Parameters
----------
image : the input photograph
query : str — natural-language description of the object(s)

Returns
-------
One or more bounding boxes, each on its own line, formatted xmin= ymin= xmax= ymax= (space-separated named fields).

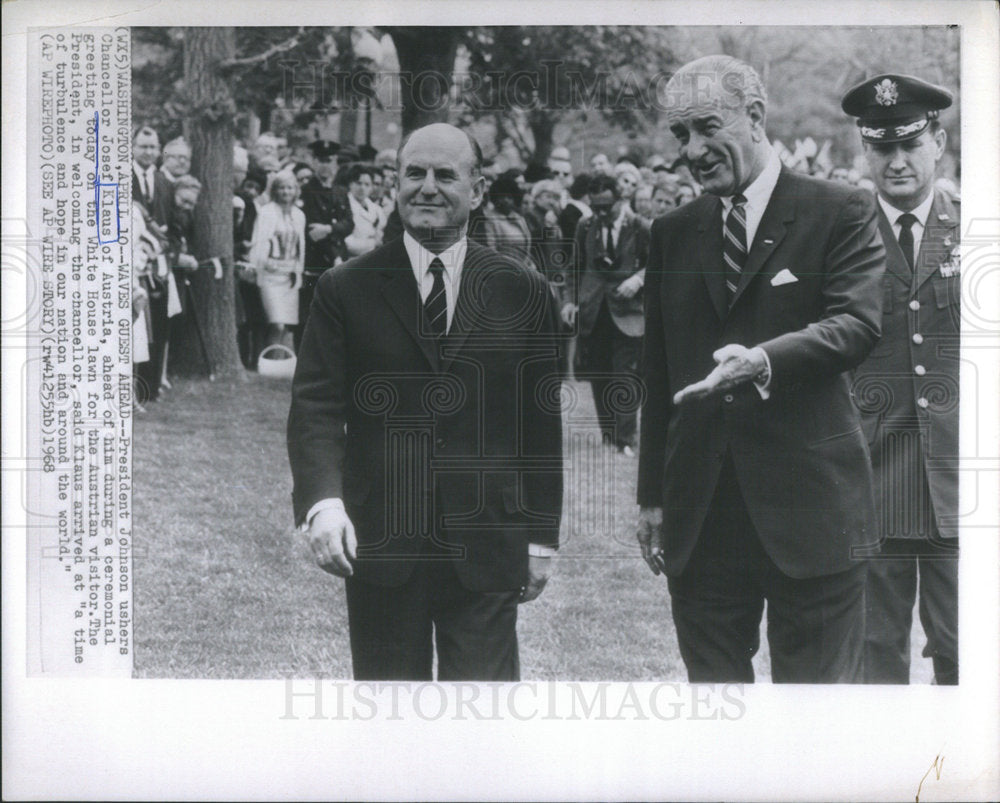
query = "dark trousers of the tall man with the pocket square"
xmin=668 ymin=453 xmax=867 ymax=683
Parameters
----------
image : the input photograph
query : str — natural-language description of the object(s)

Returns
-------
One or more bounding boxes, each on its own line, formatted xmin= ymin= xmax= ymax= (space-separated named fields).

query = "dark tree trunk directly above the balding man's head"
xmin=386 ymin=27 xmax=458 ymax=136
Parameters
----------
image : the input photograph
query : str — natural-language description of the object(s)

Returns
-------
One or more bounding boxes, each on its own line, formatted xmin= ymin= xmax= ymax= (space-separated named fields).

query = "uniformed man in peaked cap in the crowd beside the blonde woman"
xmin=295 ymin=139 xmax=354 ymax=351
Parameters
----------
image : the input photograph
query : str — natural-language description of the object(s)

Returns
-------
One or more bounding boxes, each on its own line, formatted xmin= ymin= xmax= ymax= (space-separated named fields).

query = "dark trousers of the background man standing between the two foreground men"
xmin=580 ymin=300 xmax=642 ymax=448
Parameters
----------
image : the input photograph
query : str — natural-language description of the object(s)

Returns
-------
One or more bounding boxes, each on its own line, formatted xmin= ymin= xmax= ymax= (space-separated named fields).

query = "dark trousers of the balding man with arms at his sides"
xmin=346 ymin=545 xmax=520 ymax=681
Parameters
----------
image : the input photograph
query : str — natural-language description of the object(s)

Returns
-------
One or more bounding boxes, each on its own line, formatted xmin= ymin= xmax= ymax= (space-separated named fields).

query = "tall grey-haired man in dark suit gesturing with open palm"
xmin=638 ymin=56 xmax=885 ymax=683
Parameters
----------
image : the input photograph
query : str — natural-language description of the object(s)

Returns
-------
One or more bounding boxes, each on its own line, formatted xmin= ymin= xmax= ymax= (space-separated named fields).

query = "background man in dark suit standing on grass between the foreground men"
xmin=562 ymin=175 xmax=649 ymax=457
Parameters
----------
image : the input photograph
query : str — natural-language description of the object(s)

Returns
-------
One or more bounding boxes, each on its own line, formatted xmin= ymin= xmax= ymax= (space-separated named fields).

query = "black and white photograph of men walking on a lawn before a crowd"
xmin=132 ymin=26 xmax=961 ymax=684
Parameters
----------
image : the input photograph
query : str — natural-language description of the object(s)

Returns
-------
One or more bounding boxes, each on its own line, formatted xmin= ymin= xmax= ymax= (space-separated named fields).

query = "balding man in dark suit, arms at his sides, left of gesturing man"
xmin=288 ymin=124 xmax=562 ymax=680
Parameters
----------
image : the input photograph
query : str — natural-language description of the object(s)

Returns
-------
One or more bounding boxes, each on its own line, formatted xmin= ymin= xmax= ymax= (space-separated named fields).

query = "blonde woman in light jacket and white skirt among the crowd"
xmin=249 ymin=171 xmax=306 ymax=348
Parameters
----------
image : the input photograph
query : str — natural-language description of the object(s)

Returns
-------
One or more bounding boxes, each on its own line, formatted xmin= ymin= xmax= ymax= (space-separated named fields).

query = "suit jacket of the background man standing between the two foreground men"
xmin=563 ymin=215 xmax=649 ymax=337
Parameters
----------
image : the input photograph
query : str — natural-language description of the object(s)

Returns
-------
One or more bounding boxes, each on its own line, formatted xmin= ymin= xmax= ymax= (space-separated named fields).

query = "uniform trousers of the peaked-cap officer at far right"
xmin=864 ymin=538 xmax=958 ymax=686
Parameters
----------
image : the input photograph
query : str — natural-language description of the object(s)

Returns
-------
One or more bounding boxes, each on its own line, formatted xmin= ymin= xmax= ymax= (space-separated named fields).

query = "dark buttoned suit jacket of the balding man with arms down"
xmin=288 ymin=239 xmax=562 ymax=591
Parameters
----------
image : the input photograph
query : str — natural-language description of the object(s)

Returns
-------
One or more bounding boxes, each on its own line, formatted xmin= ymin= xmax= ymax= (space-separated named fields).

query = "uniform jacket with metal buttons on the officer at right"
xmin=854 ymin=191 xmax=962 ymax=538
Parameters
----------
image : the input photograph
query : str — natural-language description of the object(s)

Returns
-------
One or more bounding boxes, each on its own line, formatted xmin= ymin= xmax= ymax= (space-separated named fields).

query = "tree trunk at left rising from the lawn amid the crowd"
xmin=170 ymin=27 xmax=243 ymax=376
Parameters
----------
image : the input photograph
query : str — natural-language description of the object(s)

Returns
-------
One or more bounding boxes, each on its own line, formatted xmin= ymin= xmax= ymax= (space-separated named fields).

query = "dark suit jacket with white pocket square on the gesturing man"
xmin=638 ymin=169 xmax=885 ymax=578
